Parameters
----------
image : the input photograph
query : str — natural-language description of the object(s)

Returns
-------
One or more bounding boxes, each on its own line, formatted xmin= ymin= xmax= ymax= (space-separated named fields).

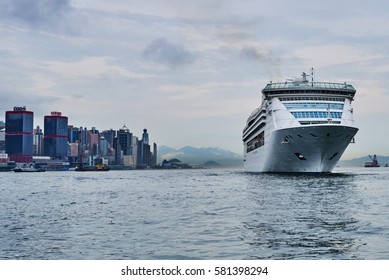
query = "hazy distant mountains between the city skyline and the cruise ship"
xmin=158 ymin=146 xmax=243 ymax=167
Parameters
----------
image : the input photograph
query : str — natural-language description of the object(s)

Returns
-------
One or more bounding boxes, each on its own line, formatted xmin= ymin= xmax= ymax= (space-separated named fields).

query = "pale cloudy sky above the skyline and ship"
xmin=0 ymin=0 xmax=389 ymax=159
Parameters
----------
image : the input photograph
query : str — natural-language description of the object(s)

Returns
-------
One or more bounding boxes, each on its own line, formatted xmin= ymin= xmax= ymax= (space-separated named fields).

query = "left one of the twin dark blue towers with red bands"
xmin=5 ymin=106 xmax=34 ymax=162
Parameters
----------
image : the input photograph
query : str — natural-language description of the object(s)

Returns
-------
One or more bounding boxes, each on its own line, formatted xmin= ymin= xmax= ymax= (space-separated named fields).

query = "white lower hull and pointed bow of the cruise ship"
xmin=244 ymin=125 xmax=358 ymax=173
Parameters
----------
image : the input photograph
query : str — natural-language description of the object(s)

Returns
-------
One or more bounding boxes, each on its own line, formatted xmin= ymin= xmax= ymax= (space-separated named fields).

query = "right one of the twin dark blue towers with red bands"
xmin=44 ymin=112 xmax=68 ymax=158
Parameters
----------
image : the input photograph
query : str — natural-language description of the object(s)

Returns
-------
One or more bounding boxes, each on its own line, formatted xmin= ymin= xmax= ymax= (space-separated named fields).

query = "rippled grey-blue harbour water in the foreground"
xmin=0 ymin=167 xmax=389 ymax=260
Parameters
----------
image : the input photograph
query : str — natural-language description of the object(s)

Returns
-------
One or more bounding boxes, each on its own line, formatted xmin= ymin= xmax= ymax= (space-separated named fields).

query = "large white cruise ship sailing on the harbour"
xmin=243 ymin=71 xmax=358 ymax=173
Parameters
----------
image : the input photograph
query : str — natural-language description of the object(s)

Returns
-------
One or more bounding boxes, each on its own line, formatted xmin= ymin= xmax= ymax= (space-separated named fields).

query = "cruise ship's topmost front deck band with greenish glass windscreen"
xmin=262 ymin=81 xmax=356 ymax=99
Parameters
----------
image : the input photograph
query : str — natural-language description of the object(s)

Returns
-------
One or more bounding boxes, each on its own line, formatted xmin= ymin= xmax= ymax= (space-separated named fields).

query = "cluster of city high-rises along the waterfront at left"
xmin=0 ymin=107 xmax=157 ymax=170
